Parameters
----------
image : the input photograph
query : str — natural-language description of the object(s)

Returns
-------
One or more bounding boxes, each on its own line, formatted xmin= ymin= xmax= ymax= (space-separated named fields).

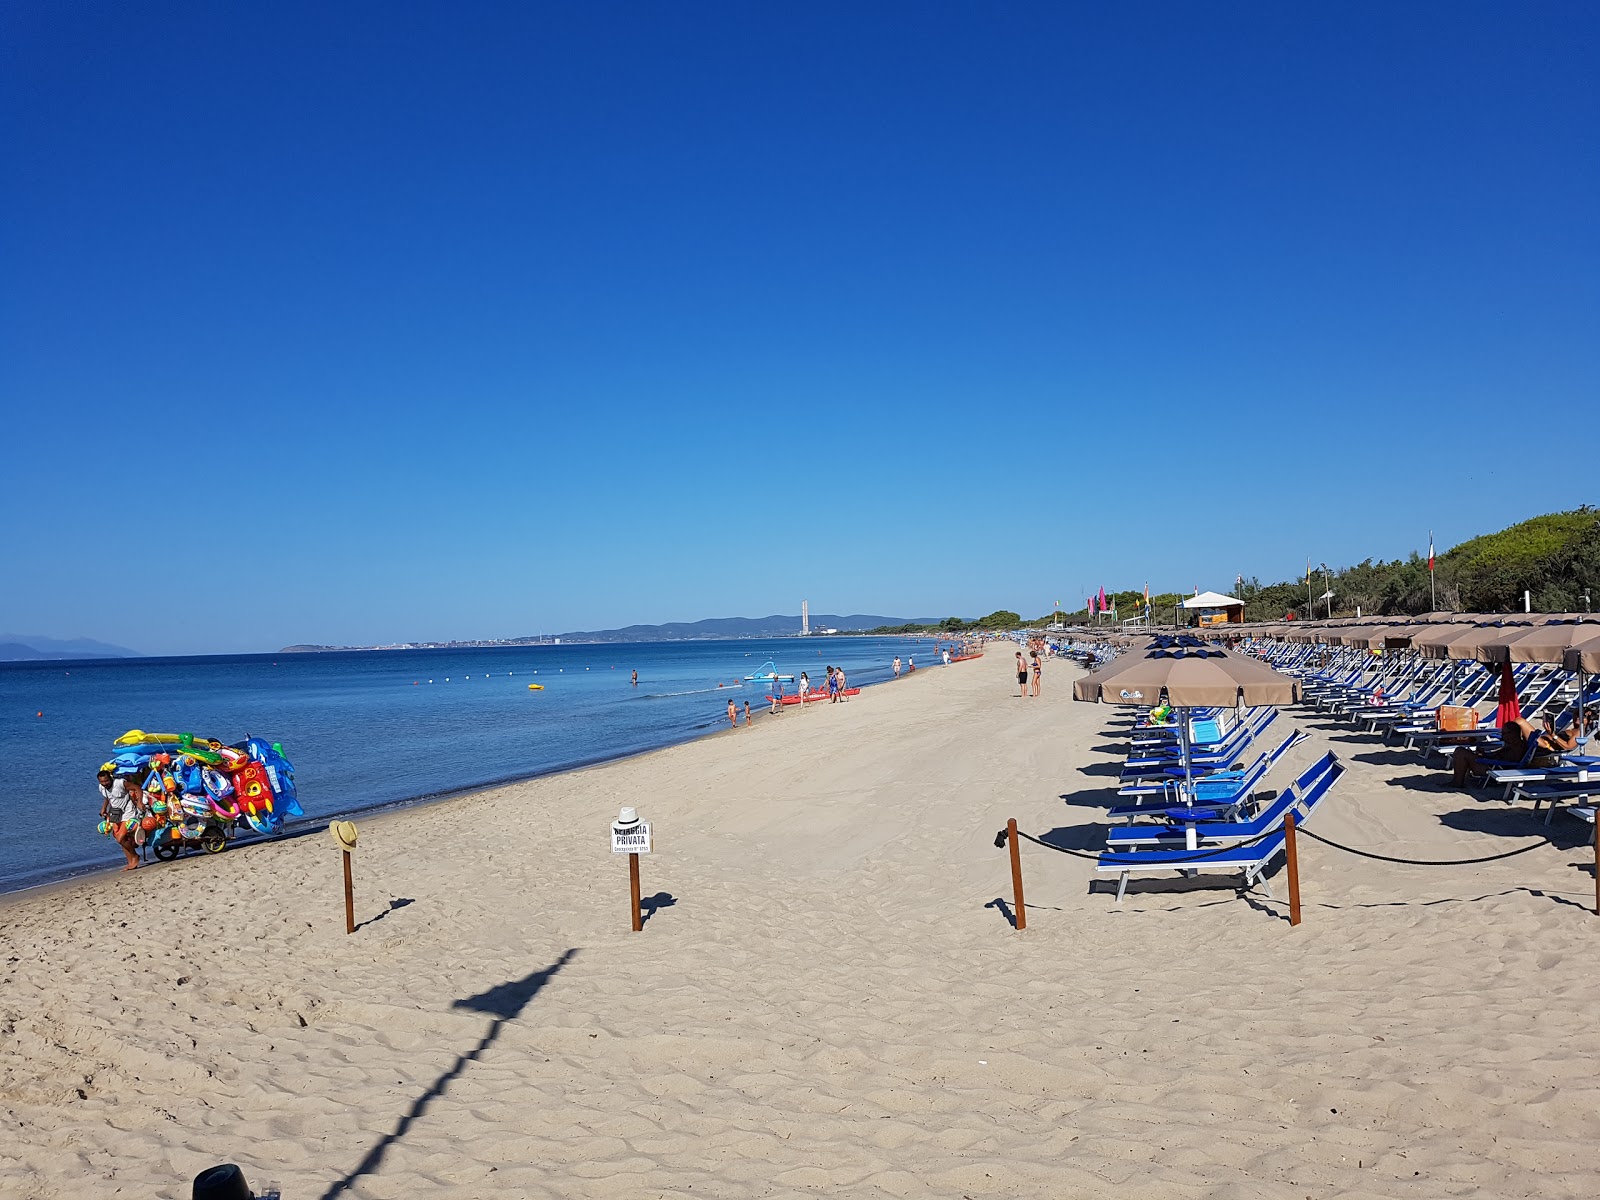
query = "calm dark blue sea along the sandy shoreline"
xmin=0 ymin=637 xmax=934 ymax=891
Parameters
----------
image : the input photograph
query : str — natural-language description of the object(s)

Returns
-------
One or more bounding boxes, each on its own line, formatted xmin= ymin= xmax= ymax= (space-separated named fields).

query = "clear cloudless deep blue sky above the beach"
xmin=0 ymin=0 xmax=1600 ymax=653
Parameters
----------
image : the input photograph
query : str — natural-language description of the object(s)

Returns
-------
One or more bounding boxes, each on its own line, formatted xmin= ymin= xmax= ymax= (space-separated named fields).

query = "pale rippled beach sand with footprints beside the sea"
xmin=0 ymin=653 xmax=1600 ymax=1200
